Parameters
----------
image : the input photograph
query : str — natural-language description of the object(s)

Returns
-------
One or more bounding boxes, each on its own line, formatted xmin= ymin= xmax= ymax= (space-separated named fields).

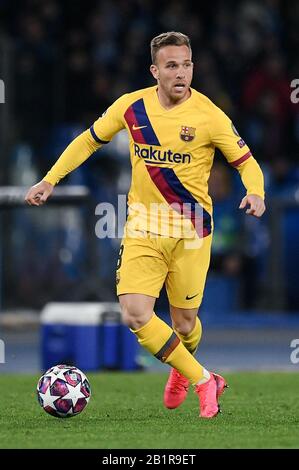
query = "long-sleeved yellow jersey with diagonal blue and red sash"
xmin=44 ymin=86 xmax=264 ymax=238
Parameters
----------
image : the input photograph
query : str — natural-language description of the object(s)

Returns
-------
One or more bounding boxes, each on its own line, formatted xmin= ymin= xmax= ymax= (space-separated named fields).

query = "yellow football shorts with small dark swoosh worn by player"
xmin=116 ymin=230 xmax=212 ymax=308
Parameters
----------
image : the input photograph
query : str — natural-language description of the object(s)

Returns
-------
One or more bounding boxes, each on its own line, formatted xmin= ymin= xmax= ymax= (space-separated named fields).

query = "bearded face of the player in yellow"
xmin=151 ymin=46 xmax=193 ymax=104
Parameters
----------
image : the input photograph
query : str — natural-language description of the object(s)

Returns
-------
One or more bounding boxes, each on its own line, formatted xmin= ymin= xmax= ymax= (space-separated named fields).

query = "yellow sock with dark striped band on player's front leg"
xmin=131 ymin=313 xmax=204 ymax=384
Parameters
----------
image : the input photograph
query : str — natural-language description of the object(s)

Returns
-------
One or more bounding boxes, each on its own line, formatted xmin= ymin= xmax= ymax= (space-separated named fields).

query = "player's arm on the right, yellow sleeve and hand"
xmin=209 ymin=106 xmax=266 ymax=217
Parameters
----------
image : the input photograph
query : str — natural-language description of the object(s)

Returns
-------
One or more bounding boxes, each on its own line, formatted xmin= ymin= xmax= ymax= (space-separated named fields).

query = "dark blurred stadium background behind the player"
xmin=0 ymin=0 xmax=299 ymax=373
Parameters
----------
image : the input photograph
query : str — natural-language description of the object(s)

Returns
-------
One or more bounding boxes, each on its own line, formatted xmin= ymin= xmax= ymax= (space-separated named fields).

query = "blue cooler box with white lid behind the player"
xmin=41 ymin=302 xmax=140 ymax=371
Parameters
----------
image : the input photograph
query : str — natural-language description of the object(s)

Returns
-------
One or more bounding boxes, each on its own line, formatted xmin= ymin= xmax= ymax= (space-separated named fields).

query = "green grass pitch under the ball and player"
xmin=0 ymin=372 xmax=299 ymax=449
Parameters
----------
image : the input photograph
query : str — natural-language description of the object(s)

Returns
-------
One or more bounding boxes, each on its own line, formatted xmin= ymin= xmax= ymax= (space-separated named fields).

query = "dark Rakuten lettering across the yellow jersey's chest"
xmin=134 ymin=144 xmax=192 ymax=163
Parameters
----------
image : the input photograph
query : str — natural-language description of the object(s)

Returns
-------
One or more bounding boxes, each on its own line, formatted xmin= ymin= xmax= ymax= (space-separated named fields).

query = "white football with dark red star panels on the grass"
xmin=37 ymin=364 xmax=91 ymax=418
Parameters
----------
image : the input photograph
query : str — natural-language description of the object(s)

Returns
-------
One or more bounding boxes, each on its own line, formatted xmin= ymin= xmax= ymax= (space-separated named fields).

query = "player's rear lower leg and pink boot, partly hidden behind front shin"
xmin=164 ymin=305 xmax=202 ymax=408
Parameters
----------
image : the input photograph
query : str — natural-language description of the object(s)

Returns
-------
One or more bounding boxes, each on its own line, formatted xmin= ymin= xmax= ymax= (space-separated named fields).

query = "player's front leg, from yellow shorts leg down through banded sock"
xmin=117 ymin=233 xmax=223 ymax=418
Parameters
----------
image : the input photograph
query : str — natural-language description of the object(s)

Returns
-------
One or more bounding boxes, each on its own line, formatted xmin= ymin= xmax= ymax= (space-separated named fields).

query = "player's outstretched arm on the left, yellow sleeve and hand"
xmin=25 ymin=95 xmax=127 ymax=206
